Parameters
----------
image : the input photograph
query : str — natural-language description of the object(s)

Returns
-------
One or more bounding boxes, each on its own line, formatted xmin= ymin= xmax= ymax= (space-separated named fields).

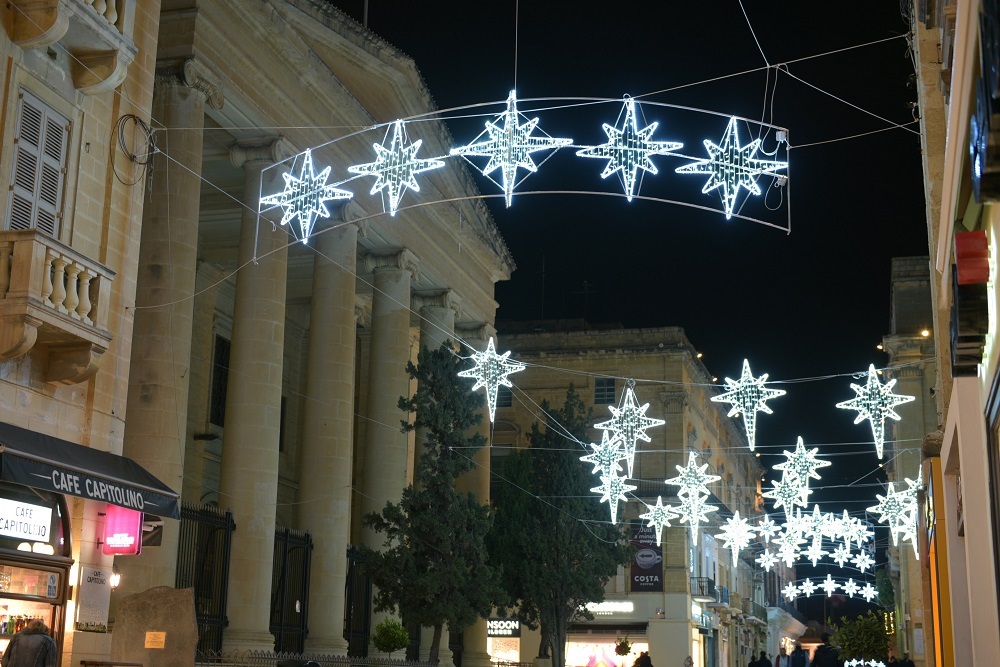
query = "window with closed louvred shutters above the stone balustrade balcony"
xmin=7 ymin=90 xmax=69 ymax=238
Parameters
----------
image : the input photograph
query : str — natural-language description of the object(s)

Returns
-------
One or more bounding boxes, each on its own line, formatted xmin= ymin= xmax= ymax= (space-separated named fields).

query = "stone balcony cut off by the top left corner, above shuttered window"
xmin=4 ymin=0 xmax=137 ymax=95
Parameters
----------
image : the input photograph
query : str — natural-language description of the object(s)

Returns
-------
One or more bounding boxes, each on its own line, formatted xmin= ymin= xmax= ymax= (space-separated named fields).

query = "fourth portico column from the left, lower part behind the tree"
xmin=360 ymin=250 xmax=419 ymax=549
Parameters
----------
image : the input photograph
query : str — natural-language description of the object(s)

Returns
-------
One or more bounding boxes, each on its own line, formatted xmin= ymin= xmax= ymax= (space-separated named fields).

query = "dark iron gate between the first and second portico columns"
xmin=174 ymin=504 xmax=236 ymax=651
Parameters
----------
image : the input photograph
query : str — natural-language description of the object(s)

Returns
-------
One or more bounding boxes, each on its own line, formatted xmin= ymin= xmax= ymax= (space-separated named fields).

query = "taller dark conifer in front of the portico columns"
xmin=362 ymin=345 xmax=500 ymax=663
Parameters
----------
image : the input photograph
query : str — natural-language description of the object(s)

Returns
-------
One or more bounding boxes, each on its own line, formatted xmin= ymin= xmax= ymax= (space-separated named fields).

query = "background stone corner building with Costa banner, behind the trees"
xmin=491 ymin=321 xmax=805 ymax=667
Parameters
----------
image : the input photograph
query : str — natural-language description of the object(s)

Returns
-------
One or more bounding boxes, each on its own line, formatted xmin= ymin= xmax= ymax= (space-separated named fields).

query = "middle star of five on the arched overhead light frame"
xmin=451 ymin=90 xmax=573 ymax=208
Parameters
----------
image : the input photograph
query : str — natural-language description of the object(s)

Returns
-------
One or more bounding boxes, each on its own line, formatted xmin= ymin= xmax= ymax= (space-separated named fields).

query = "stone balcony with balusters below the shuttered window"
xmin=0 ymin=229 xmax=115 ymax=384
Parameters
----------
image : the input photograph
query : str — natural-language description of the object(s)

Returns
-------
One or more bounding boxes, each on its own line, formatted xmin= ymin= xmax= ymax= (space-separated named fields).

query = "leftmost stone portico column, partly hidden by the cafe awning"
xmin=115 ymin=60 xmax=223 ymax=600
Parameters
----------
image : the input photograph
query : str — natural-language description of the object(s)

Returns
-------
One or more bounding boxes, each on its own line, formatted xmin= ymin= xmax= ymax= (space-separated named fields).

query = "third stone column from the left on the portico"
xmin=297 ymin=202 xmax=366 ymax=655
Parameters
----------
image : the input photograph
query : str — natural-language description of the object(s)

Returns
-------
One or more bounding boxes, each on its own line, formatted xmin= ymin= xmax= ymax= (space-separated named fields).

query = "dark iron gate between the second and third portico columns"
xmin=270 ymin=528 xmax=312 ymax=653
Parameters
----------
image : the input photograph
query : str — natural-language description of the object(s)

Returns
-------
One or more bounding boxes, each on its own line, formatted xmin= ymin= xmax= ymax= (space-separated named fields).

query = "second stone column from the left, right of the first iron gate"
xmin=219 ymin=139 xmax=292 ymax=651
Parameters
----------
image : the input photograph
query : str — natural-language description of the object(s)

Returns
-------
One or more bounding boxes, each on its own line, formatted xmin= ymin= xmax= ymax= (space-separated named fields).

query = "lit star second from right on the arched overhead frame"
xmin=576 ymin=96 xmax=684 ymax=201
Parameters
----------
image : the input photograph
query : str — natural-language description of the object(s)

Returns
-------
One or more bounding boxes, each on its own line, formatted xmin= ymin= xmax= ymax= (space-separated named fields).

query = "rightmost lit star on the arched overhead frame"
xmin=676 ymin=118 xmax=788 ymax=220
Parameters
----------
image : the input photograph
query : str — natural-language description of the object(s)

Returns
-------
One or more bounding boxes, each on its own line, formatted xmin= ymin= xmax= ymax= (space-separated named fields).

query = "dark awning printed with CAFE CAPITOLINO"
xmin=0 ymin=422 xmax=181 ymax=519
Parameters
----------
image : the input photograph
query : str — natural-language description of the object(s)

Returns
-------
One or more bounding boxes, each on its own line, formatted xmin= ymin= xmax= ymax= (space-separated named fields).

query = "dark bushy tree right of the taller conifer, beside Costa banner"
xmin=487 ymin=385 xmax=629 ymax=667
